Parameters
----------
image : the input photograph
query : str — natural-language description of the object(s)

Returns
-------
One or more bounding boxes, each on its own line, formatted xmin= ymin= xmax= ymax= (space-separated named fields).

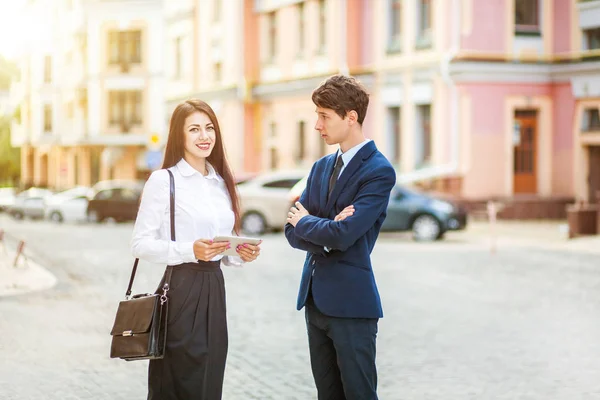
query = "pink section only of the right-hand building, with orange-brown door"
xmin=444 ymin=0 xmax=600 ymax=216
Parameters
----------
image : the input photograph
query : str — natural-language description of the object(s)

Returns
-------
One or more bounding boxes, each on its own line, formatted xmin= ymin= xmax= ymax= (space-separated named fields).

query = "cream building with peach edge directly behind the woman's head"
xmin=163 ymin=0 xmax=259 ymax=173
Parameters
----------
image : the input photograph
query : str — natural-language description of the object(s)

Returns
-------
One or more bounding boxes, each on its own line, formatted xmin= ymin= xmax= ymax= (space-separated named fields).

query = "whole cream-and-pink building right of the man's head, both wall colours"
xmin=373 ymin=0 xmax=600 ymax=217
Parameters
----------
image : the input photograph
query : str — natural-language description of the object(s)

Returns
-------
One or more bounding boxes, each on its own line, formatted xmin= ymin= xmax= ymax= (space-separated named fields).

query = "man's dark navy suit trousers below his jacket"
xmin=305 ymin=295 xmax=378 ymax=400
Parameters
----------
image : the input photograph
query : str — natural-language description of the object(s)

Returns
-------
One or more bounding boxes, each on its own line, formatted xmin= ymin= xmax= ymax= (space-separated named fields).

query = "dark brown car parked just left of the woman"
xmin=87 ymin=181 xmax=144 ymax=222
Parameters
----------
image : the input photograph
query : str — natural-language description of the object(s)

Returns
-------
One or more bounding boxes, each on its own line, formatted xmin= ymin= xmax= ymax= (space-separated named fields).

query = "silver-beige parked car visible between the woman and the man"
xmin=237 ymin=170 xmax=307 ymax=235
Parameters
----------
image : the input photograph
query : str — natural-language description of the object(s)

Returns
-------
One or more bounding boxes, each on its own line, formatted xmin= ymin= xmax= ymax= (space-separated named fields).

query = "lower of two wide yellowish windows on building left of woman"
xmin=108 ymin=90 xmax=142 ymax=132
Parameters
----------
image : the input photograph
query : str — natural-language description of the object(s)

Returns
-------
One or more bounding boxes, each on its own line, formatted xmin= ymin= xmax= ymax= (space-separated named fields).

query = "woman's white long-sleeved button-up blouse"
xmin=131 ymin=159 xmax=243 ymax=265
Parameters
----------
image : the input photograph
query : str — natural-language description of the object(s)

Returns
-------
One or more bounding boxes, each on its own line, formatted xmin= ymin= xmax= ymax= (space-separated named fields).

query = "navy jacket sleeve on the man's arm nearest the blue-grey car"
xmin=288 ymin=171 xmax=396 ymax=251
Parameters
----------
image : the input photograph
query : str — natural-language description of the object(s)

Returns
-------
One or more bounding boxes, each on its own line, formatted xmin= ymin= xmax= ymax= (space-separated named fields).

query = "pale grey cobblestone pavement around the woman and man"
xmin=0 ymin=215 xmax=600 ymax=400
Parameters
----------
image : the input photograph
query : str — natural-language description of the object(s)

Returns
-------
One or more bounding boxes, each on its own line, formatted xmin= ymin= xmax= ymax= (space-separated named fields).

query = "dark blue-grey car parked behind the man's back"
xmin=381 ymin=185 xmax=467 ymax=241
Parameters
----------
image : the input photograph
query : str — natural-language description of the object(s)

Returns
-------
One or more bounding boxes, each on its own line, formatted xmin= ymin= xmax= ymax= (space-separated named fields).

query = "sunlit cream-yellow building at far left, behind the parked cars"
xmin=12 ymin=0 xmax=165 ymax=189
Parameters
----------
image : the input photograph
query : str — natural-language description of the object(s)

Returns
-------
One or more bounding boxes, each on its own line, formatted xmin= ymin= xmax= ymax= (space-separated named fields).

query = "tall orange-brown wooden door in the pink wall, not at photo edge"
xmin=513 ymin=111 xmax=537 ymax=194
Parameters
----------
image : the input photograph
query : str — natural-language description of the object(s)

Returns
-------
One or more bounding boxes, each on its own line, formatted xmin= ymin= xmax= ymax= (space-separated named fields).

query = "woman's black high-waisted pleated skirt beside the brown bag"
xmin=148 ymin=261 xmax=228 ymax=400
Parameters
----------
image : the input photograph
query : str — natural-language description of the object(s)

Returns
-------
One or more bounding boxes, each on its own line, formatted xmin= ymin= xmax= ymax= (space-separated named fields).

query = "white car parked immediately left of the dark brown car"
xmin=45 ymin=186 xmax=90 ymax=222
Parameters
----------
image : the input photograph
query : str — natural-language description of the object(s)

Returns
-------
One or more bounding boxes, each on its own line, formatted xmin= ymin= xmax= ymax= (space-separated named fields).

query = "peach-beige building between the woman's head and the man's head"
xmin=252 ymin=0 xmax=354 ymax=169
